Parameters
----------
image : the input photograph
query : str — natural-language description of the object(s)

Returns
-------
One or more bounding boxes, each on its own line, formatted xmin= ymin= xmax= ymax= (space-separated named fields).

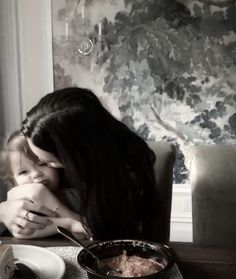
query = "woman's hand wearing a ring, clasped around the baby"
xmin=0 ymin=199 xmax=55 ymax=236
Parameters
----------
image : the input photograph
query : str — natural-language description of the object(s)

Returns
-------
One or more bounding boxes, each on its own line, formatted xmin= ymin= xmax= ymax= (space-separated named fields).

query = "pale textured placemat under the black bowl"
xmin=47 ymin=246 xmax=183 ymax=279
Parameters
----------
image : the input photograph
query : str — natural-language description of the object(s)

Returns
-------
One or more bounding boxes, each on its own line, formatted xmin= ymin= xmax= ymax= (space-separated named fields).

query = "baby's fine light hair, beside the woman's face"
xmin=0 ymin=130 xmax=38 ymax=186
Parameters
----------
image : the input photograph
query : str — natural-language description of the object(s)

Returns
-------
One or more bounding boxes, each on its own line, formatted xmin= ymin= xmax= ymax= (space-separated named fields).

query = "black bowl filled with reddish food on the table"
xmin=77 ymin=240 xmax=175 ymax=279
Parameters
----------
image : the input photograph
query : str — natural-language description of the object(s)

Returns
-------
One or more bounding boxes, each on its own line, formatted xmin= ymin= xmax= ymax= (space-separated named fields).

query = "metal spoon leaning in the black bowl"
xmin=57 ymin=226 xmax=120 ymax=276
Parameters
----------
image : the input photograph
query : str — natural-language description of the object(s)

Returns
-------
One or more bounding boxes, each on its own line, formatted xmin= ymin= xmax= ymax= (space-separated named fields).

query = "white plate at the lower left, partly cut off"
xmin=11 ymin=244 xmax=65 ymax=279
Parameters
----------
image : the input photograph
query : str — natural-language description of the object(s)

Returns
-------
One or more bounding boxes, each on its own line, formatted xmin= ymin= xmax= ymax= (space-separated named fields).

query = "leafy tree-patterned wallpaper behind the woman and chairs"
xmin=52 ymin=0 xmax=236 ymax=184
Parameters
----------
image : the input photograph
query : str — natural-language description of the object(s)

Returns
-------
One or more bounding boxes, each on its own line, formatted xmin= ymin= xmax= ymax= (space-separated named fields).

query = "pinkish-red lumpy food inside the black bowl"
xmin=103 ymin=250 xmax=164 ymax=277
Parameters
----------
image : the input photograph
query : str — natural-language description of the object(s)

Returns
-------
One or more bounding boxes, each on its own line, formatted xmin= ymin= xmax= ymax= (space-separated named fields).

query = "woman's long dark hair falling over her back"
xmin=22 ymin=88 xmax=161 ymax=241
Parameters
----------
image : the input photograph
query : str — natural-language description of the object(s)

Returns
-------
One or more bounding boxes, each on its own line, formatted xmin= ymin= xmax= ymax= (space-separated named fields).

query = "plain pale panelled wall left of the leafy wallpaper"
xmin=0 ymin=0 xmax=53 ymax=233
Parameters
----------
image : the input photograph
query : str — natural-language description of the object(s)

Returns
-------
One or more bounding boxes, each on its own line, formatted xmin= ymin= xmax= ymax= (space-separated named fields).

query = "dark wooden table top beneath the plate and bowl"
xmin=0 ymin=235 xmax=236 ymax=279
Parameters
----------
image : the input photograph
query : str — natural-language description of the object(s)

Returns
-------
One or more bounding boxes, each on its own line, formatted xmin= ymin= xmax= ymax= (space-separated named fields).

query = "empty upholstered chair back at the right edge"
xmin=187 ymin=144 xmax=236 ymax=247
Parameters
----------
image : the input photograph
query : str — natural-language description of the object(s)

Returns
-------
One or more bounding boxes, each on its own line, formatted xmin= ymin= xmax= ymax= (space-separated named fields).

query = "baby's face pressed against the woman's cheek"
xmin=10 ymin=151 xmax=59 ymax=192
